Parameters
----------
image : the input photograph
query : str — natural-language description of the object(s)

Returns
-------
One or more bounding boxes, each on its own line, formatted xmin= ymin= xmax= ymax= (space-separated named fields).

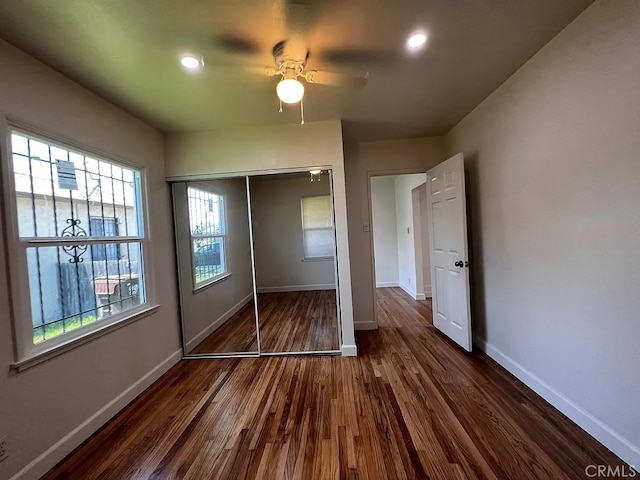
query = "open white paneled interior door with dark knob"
xmin=427 ymin=153 xmax=472 ymax=352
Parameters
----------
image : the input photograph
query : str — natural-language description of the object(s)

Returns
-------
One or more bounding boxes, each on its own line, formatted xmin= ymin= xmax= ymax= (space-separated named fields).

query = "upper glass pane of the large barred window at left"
xmin=11 ymin=132 xmax=142 ymax=239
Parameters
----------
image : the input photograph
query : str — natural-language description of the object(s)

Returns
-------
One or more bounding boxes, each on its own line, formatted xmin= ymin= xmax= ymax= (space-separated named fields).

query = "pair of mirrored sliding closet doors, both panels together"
xmin=173 ymin=169 xmax=341 ymax=358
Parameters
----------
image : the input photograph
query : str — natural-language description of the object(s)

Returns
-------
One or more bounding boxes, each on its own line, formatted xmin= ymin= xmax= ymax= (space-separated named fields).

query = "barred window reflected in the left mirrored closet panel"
xmin=187 ymin=187 xmax=227 ymax=288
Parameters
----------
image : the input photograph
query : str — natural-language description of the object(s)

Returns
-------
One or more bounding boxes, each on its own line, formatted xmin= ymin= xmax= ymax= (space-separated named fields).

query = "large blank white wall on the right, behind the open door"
xmin=449 ymin=0 xmax=640 ymax=466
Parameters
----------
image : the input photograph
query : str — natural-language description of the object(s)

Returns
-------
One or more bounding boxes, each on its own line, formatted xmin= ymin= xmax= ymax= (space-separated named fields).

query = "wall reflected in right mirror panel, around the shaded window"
xmin=250 ymin=174 xmax=336 ymax=292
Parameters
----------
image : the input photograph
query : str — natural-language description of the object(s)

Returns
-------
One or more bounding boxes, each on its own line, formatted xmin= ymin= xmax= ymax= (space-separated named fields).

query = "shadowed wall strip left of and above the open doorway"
xmin=344 ymin=137 xmax=447 ymax=329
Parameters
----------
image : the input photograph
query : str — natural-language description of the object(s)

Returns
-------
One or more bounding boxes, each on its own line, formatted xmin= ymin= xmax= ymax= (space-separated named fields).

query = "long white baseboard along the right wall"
xmin=475 ymin=337 xmax=640 ymax=466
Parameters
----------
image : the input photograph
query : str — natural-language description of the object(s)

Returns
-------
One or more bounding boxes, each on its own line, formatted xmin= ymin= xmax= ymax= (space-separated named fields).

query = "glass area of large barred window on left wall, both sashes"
xmin=6 ymin=131 xmax=145 ymax=353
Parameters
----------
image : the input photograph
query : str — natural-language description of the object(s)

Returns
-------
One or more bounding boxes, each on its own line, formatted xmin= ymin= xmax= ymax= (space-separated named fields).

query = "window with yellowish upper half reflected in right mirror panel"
xmin=302 ymin=195 xmax=335 ymax=260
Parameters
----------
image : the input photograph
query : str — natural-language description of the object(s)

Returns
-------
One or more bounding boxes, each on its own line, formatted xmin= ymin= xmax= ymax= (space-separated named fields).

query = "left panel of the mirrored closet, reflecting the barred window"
xmin=173 ymin=177 xmax=258 ymax=355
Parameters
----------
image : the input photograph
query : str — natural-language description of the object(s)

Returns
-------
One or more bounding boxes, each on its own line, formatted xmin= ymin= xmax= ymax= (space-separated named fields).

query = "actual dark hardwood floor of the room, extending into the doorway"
xmin=45 ymin=288 xmax=621 ymax=480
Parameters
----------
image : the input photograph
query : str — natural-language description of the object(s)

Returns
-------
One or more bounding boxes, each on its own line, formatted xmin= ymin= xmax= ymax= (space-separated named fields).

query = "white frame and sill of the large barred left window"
xmin=0 ymin=122 xmax=159 ymax=371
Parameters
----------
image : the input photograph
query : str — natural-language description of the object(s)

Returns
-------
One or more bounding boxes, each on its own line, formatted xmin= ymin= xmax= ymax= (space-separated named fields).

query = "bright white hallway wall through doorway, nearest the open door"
xmin=395 ymin=173 xmax=427 ymax=300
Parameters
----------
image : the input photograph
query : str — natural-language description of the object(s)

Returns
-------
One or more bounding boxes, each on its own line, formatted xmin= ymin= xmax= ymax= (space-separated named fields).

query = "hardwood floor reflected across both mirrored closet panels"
xmin=191 ymin=290 xmax=340 ymax=354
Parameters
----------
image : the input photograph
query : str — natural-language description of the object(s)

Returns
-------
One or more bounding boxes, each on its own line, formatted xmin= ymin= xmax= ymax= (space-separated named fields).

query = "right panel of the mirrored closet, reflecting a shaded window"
xmin=249 ymin=170 xmax=339 ymax=353
